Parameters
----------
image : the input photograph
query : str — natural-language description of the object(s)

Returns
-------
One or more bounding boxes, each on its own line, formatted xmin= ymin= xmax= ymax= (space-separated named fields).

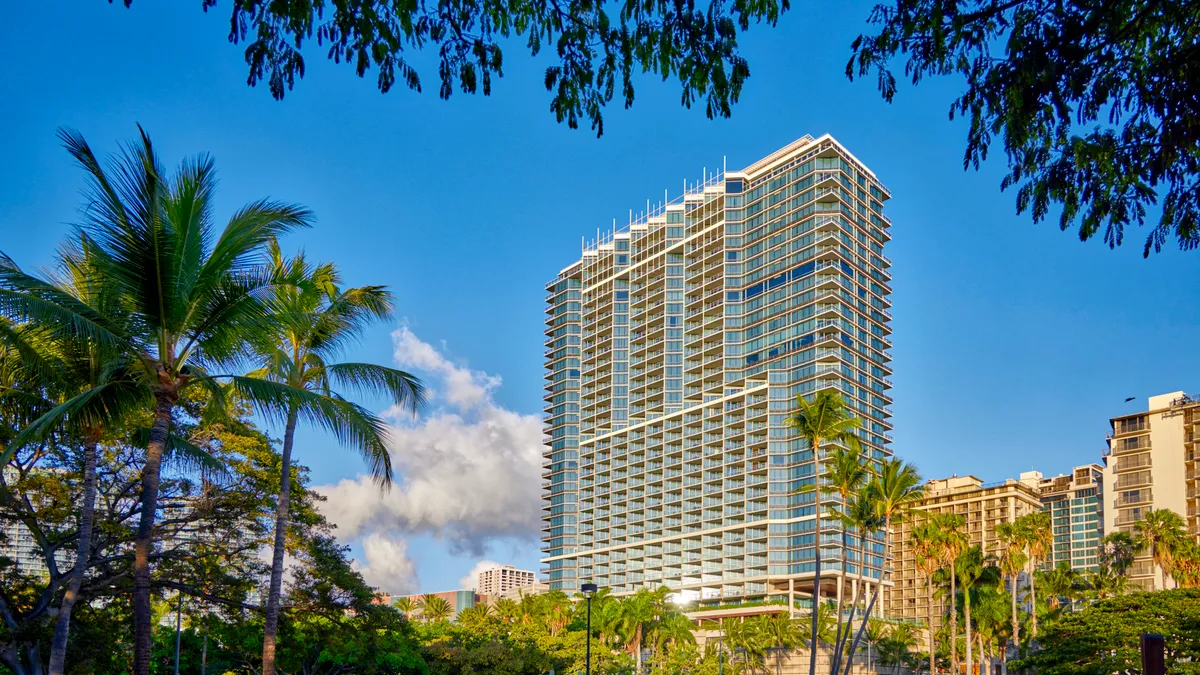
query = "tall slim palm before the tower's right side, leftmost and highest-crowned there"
xmin=785 ymin=389 xmax=862 ymax=675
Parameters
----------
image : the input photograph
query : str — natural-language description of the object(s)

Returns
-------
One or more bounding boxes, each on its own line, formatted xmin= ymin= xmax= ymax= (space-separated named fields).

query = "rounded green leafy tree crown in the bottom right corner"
xmin=1014 ymin=589 xmax=1200 ymax=675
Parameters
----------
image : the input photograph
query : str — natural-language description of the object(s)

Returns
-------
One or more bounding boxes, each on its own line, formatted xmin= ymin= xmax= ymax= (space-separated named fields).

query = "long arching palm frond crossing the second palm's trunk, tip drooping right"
xmin=230 ymin=376 xmax=392 ymax=488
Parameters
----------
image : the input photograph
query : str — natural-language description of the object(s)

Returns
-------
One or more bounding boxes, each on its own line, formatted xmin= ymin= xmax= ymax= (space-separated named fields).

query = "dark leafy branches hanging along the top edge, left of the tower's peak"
xmin=175 ymin=0 xmax=788 ymax=136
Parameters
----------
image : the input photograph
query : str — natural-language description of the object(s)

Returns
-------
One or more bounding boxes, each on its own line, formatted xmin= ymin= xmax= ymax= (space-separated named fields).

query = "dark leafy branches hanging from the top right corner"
xmin=846 ymin=0 xmax=1200 ymax=256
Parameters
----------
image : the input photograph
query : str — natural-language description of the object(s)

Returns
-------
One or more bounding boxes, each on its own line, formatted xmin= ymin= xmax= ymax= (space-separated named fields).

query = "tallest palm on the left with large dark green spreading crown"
xmin=0 ymin=131 xmax=336 ymax=675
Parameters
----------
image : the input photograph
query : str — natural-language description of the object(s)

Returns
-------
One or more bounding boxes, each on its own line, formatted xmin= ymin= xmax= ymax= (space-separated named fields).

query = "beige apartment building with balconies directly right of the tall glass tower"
xmin=886 ymin=476 xmax=1042 ymax=631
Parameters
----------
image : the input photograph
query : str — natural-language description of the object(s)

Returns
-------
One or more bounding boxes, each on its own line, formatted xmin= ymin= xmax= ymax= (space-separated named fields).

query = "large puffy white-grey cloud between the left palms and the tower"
xmin=317 ymin=327 xmax=542 ymax=556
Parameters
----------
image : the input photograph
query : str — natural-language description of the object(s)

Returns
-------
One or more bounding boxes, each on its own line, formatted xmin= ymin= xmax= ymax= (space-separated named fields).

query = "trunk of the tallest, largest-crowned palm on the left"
xmin=133 ymin=392 xmax=176 ymax=675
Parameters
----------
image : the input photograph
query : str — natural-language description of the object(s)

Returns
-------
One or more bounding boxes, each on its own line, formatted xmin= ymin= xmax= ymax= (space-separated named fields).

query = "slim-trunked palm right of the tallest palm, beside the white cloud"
xmin=247 ymin=241 xmax=424 ymax=675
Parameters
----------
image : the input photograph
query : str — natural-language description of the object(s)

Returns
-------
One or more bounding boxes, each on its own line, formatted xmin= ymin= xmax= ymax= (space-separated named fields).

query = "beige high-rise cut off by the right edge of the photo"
xmin=1104 ymin=392 xmax=1200 ymax=590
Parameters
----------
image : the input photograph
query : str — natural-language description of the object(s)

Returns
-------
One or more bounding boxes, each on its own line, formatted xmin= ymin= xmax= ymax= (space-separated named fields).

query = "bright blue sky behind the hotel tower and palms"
xmin=0 ymin=0 xmax=1200 ymax=590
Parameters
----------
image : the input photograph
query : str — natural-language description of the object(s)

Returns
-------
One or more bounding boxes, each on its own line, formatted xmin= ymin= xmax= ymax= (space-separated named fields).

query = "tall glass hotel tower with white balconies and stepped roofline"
xmin=542 ymin=136 xmax=892 ymax=604
